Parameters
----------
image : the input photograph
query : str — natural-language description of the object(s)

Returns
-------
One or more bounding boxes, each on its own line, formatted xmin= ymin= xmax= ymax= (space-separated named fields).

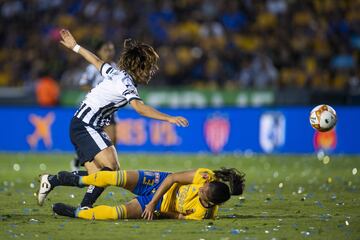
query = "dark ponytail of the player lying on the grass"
xmin=213 ymin=167 xmax=245 ymax=195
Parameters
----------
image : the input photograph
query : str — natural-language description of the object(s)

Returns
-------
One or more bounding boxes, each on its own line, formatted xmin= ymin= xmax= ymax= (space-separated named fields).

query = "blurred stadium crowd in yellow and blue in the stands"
xmin=0 ymin=0 xmax=360 ymax=91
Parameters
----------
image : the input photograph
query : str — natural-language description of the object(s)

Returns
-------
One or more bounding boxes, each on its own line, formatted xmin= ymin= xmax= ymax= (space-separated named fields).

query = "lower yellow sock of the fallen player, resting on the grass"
xmin=76 ymin=205 xmax=127 ymax=220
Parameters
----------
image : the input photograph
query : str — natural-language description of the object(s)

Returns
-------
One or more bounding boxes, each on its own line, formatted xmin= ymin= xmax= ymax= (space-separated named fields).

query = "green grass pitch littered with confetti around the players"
xmin=0 ymin=154 xmax=360 ymax=240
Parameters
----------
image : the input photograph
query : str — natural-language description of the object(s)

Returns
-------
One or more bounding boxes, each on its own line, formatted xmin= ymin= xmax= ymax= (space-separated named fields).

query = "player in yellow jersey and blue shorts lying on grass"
xmin=41 ymin=168 xmax=245 ymax=220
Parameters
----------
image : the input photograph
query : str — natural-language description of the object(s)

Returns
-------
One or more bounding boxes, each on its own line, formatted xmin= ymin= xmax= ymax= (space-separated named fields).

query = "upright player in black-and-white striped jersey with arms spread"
xmin=37 ymin=29 xmax=189 ymax=208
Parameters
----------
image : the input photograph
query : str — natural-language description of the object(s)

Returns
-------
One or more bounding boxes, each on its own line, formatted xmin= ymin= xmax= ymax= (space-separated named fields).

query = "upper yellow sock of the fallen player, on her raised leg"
xmin=80 ymin=170 xmax=126 ymax=187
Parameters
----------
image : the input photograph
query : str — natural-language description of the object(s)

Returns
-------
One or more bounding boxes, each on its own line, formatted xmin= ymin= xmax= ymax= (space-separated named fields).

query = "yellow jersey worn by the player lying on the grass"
xmin=160 ymin=168 xmax=218 ymax=220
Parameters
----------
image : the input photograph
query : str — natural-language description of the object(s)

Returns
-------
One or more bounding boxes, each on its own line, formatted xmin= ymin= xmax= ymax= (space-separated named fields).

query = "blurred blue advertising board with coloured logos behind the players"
xmin=0 ymin=106 xmax=360 ymax=154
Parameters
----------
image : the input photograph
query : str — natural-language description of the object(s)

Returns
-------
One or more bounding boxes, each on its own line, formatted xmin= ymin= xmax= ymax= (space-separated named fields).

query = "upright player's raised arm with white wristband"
xmin=60 ymin=29 xmax=104 ymax=71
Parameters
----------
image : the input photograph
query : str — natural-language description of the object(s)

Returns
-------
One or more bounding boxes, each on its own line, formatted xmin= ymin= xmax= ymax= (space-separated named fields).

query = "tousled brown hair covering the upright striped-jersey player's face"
xmin=118 ymin=39 xmax=159 ymax=84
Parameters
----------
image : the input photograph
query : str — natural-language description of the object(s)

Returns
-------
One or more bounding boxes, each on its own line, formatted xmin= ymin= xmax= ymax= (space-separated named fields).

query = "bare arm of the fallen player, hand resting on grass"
xmin=141 ymin=170 xmax=196 ymax=220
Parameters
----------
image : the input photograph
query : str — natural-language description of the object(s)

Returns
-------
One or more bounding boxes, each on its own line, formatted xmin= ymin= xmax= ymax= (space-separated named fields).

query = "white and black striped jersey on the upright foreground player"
xmin=75 ymin=63 xmax=141 ymax=128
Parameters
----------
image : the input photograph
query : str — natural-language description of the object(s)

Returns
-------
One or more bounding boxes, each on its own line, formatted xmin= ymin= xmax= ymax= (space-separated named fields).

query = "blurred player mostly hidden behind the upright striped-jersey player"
xmin=71 ymin=41 xmax=116 ymax=171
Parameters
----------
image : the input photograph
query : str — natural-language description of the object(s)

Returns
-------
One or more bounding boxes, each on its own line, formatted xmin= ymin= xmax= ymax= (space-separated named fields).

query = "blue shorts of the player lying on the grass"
xmin=133 ymin=170 xmax=170 ymax=211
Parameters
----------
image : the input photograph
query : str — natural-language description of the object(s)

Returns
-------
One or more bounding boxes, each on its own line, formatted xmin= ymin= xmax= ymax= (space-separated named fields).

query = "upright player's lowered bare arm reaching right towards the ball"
xmin=130 ymin=99 xmax=189 ymax=127
